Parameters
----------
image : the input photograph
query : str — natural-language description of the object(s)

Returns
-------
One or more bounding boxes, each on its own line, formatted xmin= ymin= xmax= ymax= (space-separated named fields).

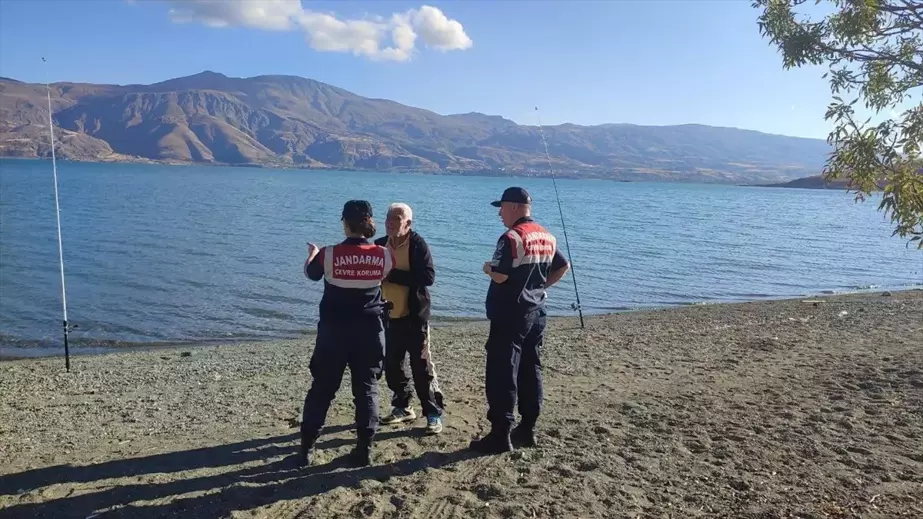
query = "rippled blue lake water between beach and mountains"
xmin=0 ymin=159 xmax=923 ymax=350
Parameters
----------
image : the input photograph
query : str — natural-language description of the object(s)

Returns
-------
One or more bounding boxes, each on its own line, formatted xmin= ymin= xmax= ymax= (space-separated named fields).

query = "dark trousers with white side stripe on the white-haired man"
xmin=385 ymin=317 xmax=444 ymax=416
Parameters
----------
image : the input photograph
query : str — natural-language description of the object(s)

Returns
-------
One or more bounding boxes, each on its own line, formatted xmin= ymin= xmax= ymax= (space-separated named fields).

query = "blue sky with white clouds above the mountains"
xmin=0 ymin=0 xmax=909 ymax=138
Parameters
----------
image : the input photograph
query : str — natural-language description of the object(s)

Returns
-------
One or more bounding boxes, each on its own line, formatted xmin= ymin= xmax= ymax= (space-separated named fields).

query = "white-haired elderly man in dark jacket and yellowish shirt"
xmin=375 ymin=203 xmax=444 ymax=434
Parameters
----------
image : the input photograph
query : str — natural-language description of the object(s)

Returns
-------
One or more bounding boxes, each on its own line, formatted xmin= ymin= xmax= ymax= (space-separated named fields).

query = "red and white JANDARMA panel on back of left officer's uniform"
xmin=324 ymin=245 xmax=393 ymax=289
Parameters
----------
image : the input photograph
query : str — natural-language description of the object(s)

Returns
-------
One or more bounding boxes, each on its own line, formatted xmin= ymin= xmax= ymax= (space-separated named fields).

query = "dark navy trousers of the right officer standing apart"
xmin=485 ymin=309 xmax=546 ymax=430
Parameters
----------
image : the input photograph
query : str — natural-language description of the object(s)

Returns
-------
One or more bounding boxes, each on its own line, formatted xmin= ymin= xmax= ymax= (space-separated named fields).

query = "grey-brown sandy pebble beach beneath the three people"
xmin=0 ymin=291 xmax=923 ymax=519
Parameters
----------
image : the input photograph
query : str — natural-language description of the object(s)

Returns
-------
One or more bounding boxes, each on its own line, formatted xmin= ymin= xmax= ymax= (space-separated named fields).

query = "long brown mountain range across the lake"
xmin=0 ymin=72 xmax=829 ymax=183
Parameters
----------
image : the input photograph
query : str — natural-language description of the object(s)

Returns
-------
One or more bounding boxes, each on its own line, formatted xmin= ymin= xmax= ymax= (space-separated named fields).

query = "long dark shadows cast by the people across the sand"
xmin=0 ymin=427 xmax=475 ymax=519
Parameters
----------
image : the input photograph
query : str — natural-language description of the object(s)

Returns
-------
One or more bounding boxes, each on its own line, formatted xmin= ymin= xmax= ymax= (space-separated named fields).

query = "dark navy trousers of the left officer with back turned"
xmin=301 ymin=317 xmax=385 ymax=442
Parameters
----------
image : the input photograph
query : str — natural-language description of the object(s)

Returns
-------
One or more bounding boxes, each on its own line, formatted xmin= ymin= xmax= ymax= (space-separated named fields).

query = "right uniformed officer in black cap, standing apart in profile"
xmin=471 ymin=187 xmax=570 ymax=454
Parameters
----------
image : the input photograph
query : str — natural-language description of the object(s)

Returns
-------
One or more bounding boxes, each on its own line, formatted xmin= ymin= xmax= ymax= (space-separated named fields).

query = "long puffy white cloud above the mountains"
xmin=159 ymin=0 xmax=473 ymax=61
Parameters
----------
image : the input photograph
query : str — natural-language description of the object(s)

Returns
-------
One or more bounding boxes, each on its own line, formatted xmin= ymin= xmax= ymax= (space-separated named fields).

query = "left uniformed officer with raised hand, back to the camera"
xmin=299 ymin=200 xmax=394 ymax=466
